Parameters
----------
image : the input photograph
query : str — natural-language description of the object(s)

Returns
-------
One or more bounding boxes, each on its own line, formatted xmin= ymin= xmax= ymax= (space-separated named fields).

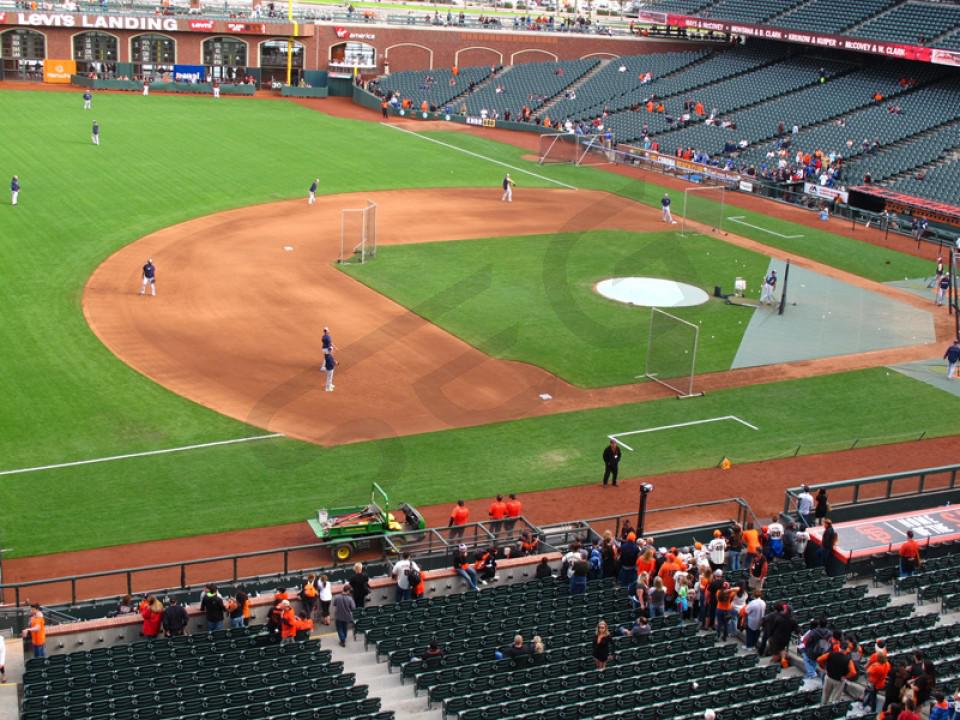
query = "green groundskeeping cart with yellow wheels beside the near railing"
xmin=307 ymin=483 xmax=427 ymax=562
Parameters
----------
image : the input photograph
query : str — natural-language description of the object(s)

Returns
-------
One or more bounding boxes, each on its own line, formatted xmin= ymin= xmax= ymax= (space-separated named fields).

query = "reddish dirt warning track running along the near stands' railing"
xmin=4 ymin=438 xmax=958 ymax=602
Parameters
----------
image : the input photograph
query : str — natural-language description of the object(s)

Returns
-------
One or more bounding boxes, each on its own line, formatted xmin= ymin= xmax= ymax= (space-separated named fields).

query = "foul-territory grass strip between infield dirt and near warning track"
xmin=0 ymin=369 xmax=960 ymax=556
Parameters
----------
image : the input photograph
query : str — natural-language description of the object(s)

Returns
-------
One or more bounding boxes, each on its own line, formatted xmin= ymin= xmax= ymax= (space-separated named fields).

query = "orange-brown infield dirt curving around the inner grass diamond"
xmin=83 ymin=189 xmax=949 ymax=445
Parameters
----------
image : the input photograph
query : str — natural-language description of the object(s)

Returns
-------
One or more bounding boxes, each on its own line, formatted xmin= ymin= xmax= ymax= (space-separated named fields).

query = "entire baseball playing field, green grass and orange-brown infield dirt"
xmin=0 ymin=90 xmax=960 ymax=562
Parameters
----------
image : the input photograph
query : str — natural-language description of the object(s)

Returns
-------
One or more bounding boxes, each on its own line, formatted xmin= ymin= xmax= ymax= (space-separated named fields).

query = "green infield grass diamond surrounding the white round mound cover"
xmin=343 ymin=230 xmax=769 ymax=386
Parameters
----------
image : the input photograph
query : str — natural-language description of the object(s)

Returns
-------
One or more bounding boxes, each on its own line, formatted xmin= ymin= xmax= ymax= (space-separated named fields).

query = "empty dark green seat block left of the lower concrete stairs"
xmin=21 ymin=628 xmax=393 ymax=720
